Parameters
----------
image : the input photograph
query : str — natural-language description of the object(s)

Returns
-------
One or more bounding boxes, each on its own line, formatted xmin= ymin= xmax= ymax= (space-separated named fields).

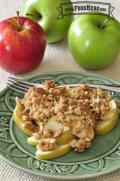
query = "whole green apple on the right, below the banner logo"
xmin=68 ymin=14 xmax=120 ymax=70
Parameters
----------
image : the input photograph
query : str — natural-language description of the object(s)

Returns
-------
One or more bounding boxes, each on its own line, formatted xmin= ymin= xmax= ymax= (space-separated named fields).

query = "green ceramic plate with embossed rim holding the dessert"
xmin=0 ymin=73 xmax=120 ymax=180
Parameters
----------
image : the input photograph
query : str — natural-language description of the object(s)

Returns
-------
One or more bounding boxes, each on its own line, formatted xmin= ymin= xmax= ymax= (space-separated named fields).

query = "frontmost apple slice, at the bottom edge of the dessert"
xmin=36 ymin=144 xmax=71 ymax=160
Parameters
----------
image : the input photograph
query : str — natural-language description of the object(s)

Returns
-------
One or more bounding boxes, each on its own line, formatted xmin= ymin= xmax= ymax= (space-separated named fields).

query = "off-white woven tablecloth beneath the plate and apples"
xmin=0 ymin=0 xmax=120 ymax=181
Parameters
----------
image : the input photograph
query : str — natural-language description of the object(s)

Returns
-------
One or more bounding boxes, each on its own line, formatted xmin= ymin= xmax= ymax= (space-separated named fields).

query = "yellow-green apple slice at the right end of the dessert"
xmin=95 ymin=100 xmax=119 ymax=135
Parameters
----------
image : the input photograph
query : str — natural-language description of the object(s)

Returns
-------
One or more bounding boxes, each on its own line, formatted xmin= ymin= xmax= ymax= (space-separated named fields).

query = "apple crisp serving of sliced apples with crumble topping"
xmin=13 ymin=80 xmax=118 ymax=159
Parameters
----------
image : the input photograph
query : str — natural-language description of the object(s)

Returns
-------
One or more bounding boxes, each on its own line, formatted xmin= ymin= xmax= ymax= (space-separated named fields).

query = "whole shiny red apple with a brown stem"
xmin=0 ymin=17 xmax=46 ymax=74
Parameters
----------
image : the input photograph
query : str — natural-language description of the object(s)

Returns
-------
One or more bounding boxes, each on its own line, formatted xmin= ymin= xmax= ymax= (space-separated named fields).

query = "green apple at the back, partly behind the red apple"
xmin=22 ymin=0 xmax=73 ymax=43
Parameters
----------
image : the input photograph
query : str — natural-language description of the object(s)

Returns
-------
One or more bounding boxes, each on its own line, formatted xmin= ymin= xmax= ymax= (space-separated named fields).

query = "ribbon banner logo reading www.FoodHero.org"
xmin=57 ymin=1 xmax=115 ymax=19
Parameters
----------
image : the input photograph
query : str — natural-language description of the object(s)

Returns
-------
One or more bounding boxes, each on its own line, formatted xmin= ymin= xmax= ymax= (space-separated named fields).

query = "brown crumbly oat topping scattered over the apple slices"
xmin=16 ymin=80 xmax=111 ymax=152
